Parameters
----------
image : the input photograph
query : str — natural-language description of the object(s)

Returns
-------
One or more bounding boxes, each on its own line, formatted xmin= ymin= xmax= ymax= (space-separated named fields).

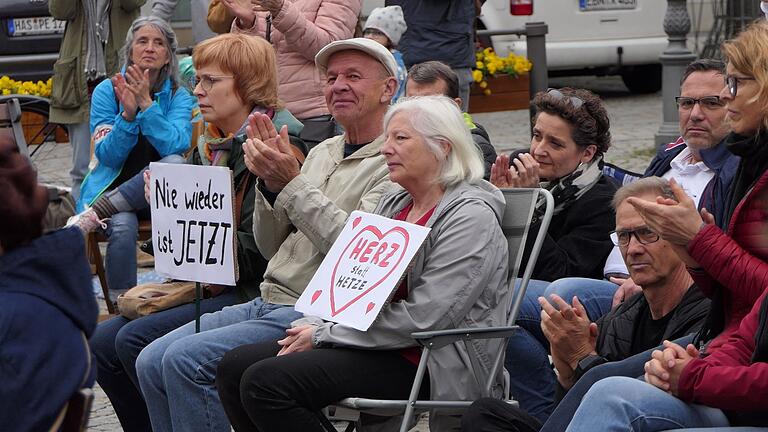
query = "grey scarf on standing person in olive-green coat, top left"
xmin=82 ymin=0 xmax=112 ymax=81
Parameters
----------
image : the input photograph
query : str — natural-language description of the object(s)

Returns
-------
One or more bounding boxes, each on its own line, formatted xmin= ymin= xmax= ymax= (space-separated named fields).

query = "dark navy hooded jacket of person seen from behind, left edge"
xmin=0 ymin=227 xmax=98 ymax=432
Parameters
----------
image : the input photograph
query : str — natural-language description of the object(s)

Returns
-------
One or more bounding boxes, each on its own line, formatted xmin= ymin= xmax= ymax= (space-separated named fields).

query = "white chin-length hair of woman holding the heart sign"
xmin=384 ymin=96 xmax=485 ymax=187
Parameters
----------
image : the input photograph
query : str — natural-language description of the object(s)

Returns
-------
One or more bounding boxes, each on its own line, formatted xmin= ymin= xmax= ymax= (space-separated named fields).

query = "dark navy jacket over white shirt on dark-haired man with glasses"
xmin=643 ymin=137 xmax=739 ymax=228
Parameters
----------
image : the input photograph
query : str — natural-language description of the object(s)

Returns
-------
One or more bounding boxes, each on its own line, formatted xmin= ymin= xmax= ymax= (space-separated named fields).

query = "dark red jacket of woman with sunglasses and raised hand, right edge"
xmin=688 ymin=167 xmax=768 ymax=351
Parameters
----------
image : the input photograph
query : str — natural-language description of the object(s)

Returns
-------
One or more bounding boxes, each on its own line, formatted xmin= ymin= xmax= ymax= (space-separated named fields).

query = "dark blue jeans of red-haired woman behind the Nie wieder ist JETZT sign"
xmin=90 ymin=289 xmax=240 ymax=432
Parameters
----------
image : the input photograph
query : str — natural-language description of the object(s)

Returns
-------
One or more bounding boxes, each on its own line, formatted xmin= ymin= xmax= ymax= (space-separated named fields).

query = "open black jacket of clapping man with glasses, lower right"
xmin=595 ymin=285 xmax=709 ymax=361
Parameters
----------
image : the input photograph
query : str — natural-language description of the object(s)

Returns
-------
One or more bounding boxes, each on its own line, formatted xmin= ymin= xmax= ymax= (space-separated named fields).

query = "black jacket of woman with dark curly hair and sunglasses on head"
xmin=519 ymin=176 xmax=616 ymax=281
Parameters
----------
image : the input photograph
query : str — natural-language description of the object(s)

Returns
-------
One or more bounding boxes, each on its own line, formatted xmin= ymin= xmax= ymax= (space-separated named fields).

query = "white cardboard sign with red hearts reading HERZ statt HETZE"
xmin=295 ymin=211 xmax=430 ymax=331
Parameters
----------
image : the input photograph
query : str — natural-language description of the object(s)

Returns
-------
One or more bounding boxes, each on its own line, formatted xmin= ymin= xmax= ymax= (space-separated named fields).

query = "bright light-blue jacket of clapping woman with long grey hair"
xmin=77 ymin=76 xmax=197 ymax=211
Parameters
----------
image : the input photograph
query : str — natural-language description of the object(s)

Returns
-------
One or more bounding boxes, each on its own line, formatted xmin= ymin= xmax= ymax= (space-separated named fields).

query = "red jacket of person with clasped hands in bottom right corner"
xmin=678 ymin=290 xmax=768 ymax=413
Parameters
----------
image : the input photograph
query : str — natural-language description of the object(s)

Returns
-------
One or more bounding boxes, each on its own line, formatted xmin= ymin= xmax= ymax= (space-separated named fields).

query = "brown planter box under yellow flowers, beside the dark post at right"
xmin=469 ymin=74 xmax=531 ymax=113
